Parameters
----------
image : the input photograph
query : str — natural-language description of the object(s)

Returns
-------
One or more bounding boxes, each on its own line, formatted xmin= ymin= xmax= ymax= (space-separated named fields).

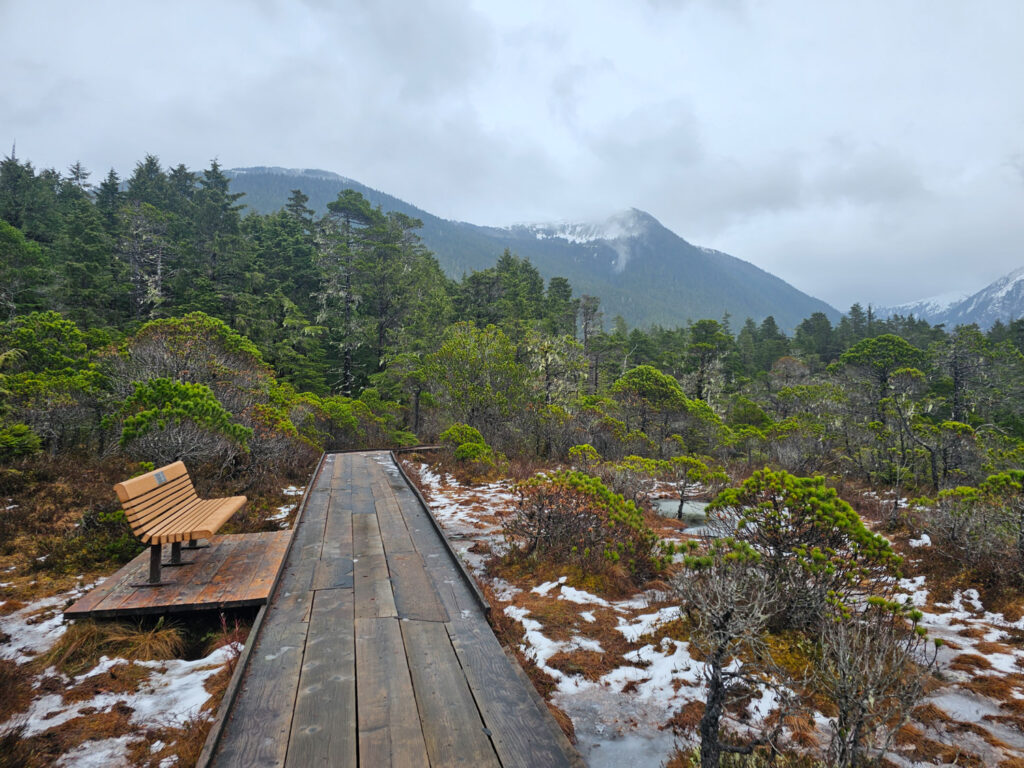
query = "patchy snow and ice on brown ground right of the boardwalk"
xmin=407 ymin=464 xmax=1024 ymax=768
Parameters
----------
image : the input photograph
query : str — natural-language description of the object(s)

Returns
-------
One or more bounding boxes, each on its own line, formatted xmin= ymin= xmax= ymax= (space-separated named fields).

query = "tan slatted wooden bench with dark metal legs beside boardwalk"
xmin=114 ymin=462 xmax=246 ymax=586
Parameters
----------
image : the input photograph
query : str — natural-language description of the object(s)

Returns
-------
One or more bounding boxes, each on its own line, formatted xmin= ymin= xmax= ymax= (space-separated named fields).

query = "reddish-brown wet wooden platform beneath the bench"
xmin=65 ymin=530 xmax=291 ymax=618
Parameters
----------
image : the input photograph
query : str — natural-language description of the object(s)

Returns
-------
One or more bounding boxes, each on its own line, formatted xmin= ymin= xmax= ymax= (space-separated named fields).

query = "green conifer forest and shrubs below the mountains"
xmin=6 ymin=155 xmax=1024 ymax=768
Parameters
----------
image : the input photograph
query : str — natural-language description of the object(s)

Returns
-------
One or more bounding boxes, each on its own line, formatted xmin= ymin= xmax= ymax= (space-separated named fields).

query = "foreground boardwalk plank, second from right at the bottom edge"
xmin=401 ymin=622 xmax=497 ymax=768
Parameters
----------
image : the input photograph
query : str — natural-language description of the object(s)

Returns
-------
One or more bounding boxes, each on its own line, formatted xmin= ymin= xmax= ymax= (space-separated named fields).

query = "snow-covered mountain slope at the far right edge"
xmin=876 ymin=267 xmax=1024 ymax=329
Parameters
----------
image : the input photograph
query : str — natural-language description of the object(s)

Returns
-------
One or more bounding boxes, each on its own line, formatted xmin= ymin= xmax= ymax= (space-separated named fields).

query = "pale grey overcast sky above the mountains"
xmin=0 ymin=0 xmax=1024 ymax=309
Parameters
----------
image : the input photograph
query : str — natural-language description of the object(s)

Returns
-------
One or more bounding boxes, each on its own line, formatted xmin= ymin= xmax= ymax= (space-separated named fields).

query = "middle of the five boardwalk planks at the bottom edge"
xmin=355 ymin=617 xmax=429 ymax=768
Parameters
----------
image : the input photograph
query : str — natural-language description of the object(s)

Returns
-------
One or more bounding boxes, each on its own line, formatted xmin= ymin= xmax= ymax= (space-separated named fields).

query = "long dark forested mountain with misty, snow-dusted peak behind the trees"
xmin=227 ymin=167 xmax=840 ymax=330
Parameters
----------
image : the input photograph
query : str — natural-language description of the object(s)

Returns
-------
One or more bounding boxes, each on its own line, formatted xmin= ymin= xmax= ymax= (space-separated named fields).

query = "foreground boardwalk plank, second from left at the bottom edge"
xmin=286 ymin=589 xmax=356 ymax=768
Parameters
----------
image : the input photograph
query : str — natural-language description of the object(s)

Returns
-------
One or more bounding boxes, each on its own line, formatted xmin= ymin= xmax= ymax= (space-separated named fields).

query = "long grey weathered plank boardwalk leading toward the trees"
xmin=201 ymin=452 xmax=582 ymax=768
